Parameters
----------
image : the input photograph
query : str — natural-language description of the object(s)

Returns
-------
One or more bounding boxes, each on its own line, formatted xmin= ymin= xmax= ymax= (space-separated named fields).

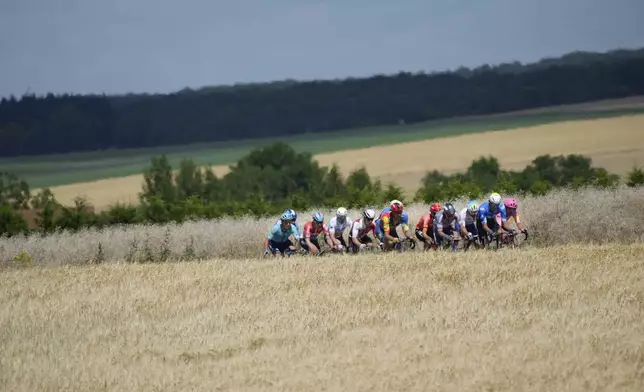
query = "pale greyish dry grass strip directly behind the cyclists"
xmin=0 ymin=187 xmax=644 ymax=266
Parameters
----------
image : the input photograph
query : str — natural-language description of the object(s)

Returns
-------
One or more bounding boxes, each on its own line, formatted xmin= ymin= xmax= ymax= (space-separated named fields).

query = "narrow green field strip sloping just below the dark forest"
xmin=5 ymin=107 xmax=644 ymax=188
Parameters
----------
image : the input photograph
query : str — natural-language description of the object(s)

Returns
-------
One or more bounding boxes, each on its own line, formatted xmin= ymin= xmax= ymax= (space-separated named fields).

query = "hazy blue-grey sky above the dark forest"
xmin=0 ymin=0 xmax=644 ymax=96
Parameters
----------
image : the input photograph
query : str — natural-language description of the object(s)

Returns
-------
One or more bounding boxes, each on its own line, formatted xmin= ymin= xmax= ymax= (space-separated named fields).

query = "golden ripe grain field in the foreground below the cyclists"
xmin=0 ymin=244 xmax=644 ymax=392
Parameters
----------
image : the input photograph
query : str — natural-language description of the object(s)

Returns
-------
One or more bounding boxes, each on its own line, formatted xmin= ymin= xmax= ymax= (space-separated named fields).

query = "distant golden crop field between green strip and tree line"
xmin=46 ymin=115 xmax=644 ymax=210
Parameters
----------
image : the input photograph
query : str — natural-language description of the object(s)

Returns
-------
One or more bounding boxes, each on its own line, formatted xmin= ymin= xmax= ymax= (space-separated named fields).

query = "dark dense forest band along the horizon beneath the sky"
xmin=0 ymin=49 xmax=644 ymax=157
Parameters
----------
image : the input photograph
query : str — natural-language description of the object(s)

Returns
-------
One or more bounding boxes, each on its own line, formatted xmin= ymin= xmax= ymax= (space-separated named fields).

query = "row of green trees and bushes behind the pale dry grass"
xmin=0 ymin=143 xmax=644 ymax=235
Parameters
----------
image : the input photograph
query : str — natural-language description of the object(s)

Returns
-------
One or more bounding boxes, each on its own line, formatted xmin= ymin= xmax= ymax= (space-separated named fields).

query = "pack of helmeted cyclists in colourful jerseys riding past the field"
xmin=264 ymin=192 xmax=528 ymax=255
